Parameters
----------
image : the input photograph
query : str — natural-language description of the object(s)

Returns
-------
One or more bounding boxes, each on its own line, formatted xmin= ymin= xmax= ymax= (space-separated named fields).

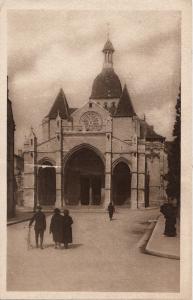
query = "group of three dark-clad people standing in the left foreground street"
xmin=29 ymin=206 xmax=73 ymax=249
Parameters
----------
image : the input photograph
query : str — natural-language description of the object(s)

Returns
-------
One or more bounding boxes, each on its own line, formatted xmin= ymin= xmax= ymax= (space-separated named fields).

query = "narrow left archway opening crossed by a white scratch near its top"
xmin=38 ymin=161 xmax=56 ymax=206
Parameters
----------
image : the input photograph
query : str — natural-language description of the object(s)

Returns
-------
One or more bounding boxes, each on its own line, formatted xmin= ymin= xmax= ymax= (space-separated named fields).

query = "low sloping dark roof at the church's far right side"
xmin=140 ymin=120 xmax=165 ymax=142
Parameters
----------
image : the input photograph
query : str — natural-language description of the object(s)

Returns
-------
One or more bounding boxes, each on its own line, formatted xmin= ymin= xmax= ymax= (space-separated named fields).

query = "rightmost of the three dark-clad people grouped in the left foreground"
xmin=63 ymin=209 xmax=73 ymax=249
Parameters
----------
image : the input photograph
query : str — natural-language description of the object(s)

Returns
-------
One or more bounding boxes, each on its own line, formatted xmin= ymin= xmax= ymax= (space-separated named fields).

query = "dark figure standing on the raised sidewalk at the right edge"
xmin=160 ymin=198 xmax=177 ymax=237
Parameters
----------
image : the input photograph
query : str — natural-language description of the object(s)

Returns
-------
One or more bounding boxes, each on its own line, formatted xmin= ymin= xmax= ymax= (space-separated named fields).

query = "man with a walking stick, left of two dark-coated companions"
xmin=29 ymin=206 xmax=46 ymax=249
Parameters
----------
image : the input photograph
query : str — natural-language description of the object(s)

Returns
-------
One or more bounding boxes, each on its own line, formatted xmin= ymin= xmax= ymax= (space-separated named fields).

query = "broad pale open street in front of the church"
xmin=7 ymin=210 xmax=180 ymax=292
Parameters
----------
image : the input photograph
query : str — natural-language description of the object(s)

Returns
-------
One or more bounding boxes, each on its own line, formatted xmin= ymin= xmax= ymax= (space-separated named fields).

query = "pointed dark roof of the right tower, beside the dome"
xmin=115 ymin=85 xmax=136 ymax=117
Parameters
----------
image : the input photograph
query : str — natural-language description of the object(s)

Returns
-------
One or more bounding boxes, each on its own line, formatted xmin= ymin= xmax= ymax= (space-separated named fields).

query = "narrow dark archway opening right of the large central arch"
xmin=112 ymin=162 xmax=131 ymax=205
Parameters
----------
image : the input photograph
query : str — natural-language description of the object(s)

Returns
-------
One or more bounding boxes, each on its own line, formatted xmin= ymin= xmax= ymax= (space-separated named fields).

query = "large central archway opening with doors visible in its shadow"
xmin=64 ymin=148 xmax=105 ymax=205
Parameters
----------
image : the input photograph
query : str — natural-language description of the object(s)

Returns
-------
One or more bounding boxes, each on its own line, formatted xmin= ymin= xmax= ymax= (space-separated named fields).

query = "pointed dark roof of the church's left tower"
xmin=47 ymin=89 xmax=70 ymax=120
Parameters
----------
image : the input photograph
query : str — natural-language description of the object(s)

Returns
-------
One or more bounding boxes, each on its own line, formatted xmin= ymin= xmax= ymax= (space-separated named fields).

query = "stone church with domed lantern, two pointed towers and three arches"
xmin=24 ymin=39 xmax=167 ymax=209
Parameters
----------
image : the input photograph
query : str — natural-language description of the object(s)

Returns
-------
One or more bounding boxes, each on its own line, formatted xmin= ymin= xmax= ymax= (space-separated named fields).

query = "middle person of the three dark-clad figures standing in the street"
xmin=50 ymin=208 xmax=63 ymax=249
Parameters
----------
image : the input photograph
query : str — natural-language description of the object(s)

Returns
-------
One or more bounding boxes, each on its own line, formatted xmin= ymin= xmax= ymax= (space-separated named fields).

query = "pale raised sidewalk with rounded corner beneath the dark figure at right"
xmin=145 ymin=215 xmax=180 ymax=259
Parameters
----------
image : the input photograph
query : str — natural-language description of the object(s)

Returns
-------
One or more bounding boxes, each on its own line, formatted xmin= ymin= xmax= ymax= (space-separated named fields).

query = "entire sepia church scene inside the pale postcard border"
xmin=2 ymin=1 xmax=191 ymax=299
